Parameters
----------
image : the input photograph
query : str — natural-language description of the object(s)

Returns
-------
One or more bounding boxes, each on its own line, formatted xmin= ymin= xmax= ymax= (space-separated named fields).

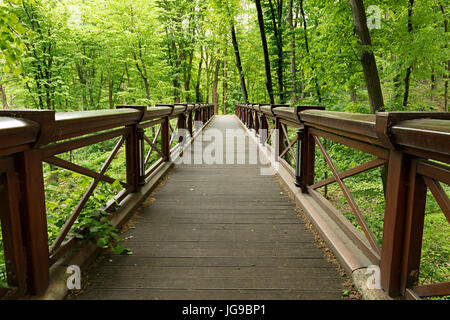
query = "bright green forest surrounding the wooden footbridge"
xmin=0 ymin=0 xmax=450 ymax=298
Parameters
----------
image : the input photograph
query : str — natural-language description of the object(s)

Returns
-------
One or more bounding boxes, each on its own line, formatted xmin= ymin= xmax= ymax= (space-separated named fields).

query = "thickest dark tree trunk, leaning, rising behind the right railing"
xmin=350 ymin=0 xmax=384 ymax=113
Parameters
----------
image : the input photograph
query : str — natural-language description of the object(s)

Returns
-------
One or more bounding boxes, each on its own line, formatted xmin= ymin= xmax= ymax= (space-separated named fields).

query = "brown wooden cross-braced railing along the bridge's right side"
xmin=236 ymin=104 xmax=450 ymax=298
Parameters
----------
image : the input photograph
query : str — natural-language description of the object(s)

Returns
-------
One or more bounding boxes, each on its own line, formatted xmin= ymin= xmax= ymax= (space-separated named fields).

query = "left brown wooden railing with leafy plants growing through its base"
xmin=0 ymin=104 xmax=214 ymax=298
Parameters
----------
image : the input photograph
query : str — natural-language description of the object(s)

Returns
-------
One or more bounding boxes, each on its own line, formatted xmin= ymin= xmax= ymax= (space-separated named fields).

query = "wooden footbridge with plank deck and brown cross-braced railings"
xmin=0 ymin=104 xmax=450 ymax=300
